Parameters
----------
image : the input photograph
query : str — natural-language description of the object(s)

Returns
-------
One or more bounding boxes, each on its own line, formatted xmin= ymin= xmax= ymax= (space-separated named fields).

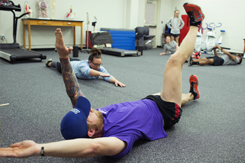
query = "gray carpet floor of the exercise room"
xmin=0 ymin=49 xmax=245 ymax=163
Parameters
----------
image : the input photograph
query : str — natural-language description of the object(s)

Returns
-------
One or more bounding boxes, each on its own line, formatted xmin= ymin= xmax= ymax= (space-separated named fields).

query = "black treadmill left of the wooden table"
xmin=0 ymin=1 xmax=46 ymax=62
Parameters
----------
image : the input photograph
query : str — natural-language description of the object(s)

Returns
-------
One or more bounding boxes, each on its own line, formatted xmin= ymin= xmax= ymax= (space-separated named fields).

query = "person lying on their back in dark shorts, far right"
xmin=188 ymin=45 xmax=242 ymax=66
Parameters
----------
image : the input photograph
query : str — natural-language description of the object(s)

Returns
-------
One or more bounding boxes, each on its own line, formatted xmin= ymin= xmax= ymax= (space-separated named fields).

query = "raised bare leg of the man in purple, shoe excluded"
xmin=160 ymin=26 xmax=198 ymax=107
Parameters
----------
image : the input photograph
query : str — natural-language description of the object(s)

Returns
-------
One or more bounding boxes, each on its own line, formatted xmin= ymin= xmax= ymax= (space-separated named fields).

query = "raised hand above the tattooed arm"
xmin=55 ymin=28 xmax=72 ymax=58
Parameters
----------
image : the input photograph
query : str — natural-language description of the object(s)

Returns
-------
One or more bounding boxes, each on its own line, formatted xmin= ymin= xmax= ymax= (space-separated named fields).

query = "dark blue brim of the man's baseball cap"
xmin=75 ymin=96 xmax=91 ymax=117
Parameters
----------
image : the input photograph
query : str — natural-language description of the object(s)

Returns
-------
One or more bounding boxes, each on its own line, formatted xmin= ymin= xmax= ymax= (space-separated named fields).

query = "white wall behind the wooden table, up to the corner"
xmin=0 ymin=0 xmax=125 ymax=48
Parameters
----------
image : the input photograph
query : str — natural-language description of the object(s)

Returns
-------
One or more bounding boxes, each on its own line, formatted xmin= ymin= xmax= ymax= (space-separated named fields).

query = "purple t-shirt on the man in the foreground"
xmin=97 ymin=99 xmax=167 ymax=158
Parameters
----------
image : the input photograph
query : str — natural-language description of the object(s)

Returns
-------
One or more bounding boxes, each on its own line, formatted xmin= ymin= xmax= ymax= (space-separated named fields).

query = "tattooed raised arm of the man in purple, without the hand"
xmin=60 ymin=58 xmax=83 ymax=107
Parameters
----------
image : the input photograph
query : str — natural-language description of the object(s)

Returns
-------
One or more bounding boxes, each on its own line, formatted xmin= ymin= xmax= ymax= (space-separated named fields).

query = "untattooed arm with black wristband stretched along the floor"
xmin=0 ymin=137 xmax=126 ymax=158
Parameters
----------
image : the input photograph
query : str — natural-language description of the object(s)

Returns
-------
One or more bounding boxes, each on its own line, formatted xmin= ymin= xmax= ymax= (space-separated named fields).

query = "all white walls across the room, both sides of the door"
xmin=0 ymin=0 xmax=245 ymax=50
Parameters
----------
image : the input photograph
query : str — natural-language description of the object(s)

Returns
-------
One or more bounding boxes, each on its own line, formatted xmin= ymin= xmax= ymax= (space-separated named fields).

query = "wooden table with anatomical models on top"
xmin=22 ymin=18 xmax=83 ymax=50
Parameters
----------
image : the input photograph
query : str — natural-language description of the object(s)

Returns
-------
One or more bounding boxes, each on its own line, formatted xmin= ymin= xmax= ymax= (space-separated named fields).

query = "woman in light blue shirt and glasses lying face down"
xmin=45 ymin=48 xmax=126 ymax=87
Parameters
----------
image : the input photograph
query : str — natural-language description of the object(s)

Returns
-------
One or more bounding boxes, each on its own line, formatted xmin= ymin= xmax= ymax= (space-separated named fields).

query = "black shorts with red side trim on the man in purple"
xmin=144 ymin=95 xmax=182 ymax=128
